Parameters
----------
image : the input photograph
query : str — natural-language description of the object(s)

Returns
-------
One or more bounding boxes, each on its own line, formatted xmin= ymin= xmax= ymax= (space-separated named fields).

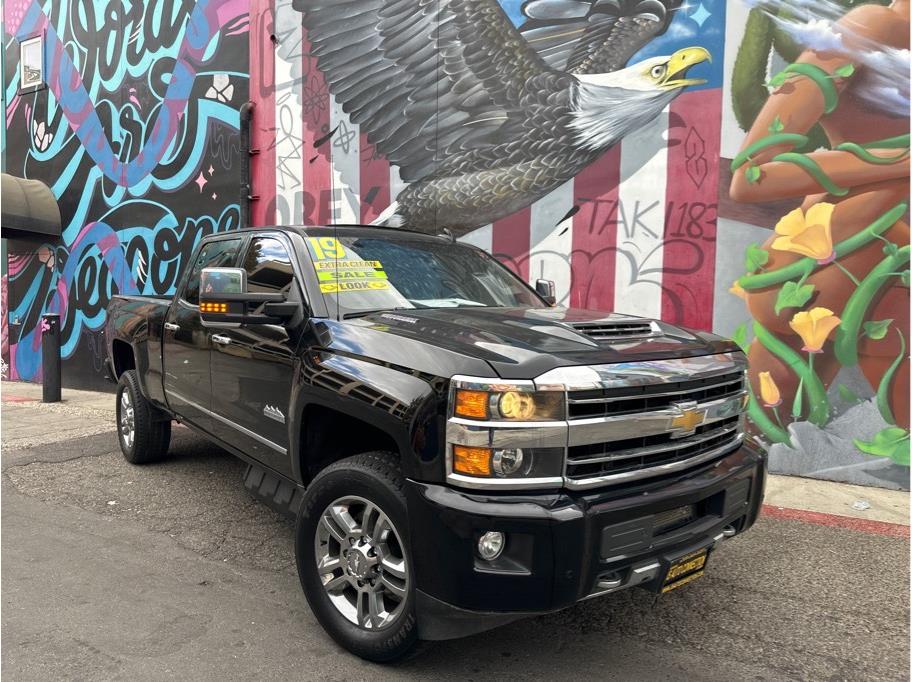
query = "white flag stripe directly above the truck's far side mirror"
xmin=529 ymin=180 xmax=573 ymax=303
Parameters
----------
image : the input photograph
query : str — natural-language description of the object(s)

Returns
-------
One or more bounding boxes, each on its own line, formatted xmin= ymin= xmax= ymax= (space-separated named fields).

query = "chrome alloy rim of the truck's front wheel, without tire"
xmin=314 ymin=496 xmax=409 ymax=630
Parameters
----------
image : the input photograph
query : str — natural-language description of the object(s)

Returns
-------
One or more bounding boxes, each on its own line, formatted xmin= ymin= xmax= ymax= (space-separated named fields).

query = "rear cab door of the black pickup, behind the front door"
xmin=162 ymin=236 xmax=244 ymax=433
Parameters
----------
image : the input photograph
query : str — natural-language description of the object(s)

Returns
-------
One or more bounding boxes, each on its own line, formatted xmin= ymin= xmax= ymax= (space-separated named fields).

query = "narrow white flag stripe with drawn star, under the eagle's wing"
xmin=328 ymin=97 xmax=361 ymax=224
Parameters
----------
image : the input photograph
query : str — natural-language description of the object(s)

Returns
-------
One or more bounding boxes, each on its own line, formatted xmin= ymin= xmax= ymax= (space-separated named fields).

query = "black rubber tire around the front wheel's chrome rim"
xmin=295 ymin=452 xmax=418 ymax=663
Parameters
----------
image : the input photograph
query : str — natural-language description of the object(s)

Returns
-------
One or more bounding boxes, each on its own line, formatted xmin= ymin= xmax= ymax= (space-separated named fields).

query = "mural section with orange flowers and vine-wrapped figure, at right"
xmin=716 ymin=1 xmax=909 ymax=487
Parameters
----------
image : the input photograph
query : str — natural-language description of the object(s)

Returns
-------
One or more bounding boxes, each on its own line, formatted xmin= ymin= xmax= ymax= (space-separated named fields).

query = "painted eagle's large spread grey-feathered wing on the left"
xmin=295 ymin=0 xmax=551 ymax=182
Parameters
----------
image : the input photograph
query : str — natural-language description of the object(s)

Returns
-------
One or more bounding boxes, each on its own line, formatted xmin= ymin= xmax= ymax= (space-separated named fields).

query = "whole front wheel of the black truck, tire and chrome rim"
xmin=295 ymin=452 xmax=418 ymax=662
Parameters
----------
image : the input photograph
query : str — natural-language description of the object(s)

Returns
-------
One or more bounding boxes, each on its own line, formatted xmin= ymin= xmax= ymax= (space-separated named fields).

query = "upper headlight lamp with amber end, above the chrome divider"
xmin=453 ymin=387 xmax=564 ymax=422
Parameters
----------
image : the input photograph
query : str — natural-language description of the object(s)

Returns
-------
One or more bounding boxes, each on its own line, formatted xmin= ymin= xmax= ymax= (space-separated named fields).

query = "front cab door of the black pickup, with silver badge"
xmin=209 ymin=234 xmax=302 ymax=474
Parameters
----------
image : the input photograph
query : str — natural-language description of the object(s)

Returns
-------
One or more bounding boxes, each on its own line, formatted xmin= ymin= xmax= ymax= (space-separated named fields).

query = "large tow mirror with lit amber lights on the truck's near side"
xmin=199 ymin=268 xmax=301 ymax=327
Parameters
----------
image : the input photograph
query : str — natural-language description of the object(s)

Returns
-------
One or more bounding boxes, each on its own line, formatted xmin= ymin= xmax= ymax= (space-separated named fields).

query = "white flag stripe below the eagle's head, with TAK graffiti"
xmin=614 ymin=107 xmax=668 ymax=319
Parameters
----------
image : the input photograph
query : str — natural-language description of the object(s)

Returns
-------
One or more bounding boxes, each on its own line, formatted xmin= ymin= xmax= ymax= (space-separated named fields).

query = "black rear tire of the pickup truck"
xmin=116 ymin=369 xmax=171 ymax=464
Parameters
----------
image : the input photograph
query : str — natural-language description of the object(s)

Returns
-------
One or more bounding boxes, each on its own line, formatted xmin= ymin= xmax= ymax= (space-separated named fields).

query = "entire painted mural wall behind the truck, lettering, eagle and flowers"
xmin=3 ymin=0 xmax=910 ymax=487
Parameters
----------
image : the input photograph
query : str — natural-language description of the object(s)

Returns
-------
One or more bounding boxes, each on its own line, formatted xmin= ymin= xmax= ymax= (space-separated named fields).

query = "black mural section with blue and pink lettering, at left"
xmin=3 ymin=0 xmax=248 ymax=386
